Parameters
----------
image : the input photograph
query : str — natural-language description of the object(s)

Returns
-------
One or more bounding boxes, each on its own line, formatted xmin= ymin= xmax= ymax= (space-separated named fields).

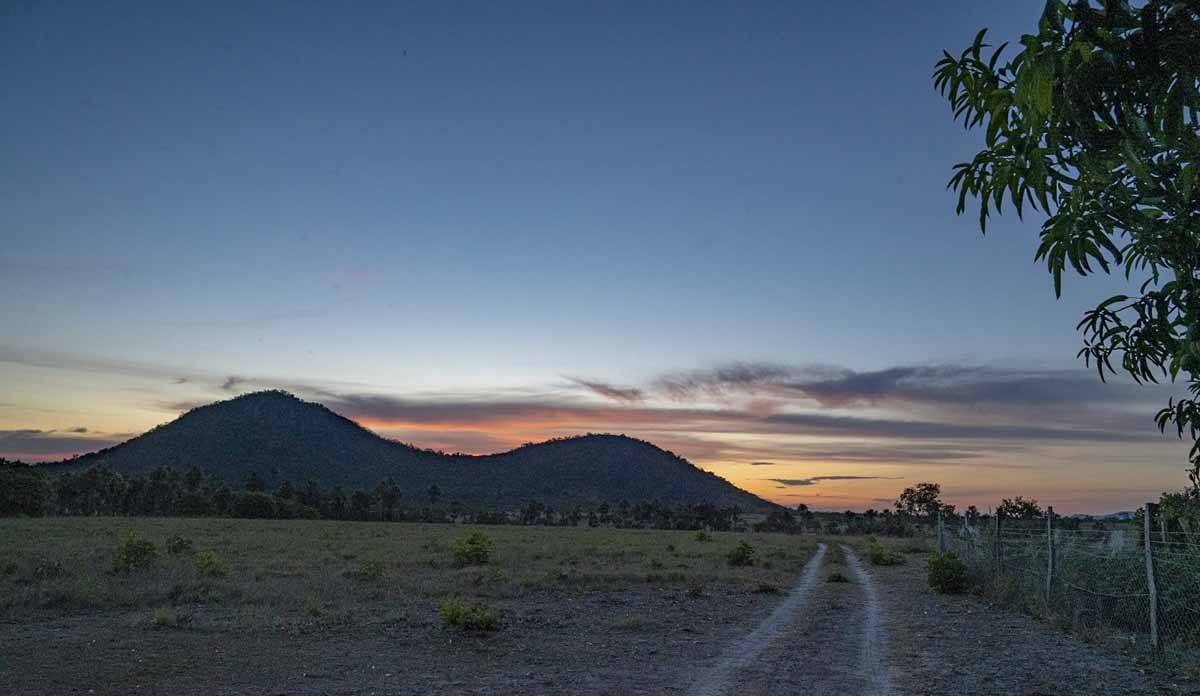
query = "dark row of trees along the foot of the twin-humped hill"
xmin=0 ymin=460 xmax=742 ymax=530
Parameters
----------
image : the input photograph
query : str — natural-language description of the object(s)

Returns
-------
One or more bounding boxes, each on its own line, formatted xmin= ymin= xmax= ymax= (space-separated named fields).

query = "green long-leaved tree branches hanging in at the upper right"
xmin=934 ymin=0 xmax=1200 ymax=493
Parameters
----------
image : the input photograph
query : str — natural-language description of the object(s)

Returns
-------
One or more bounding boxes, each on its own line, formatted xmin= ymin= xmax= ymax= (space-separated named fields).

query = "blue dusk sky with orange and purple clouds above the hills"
xmin=0 ymin=0 xmax=1187 ymax=512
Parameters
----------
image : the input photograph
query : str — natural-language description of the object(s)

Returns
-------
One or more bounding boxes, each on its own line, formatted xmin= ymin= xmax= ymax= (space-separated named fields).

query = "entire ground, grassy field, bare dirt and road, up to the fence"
xmin=0 ymin=518 xmax=1200 ymax=695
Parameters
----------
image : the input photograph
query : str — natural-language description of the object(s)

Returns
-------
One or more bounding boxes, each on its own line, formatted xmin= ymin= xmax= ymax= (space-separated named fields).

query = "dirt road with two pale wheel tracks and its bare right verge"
xmin=689 ymin=546 xmax=1200 ymax=696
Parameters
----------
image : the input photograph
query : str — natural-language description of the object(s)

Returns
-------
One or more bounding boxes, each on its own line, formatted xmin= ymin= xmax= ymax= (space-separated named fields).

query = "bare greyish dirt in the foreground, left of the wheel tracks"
xmin=0 ymin=578 xmax=801 ymax=696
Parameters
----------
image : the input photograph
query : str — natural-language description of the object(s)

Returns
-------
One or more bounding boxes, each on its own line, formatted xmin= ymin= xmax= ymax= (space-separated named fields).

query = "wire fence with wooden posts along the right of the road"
xmin=938 ymin=512 xmax=1200 ymax=649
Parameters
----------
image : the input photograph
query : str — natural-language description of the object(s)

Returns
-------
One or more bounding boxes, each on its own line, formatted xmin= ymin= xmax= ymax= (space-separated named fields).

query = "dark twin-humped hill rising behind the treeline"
xmin=44 ymin=391 xmax=774 ymax=510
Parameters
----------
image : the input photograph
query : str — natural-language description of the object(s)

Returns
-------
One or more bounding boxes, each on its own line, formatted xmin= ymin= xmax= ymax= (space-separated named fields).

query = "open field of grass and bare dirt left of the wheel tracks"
xmin=0 ymin=517 xmax=816 ymax=695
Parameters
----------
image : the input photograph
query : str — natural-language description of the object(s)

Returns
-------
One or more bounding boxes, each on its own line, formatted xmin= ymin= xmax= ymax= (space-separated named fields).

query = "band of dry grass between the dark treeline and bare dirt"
xmin=0 ymin=517 xmax=815 ymax=625
